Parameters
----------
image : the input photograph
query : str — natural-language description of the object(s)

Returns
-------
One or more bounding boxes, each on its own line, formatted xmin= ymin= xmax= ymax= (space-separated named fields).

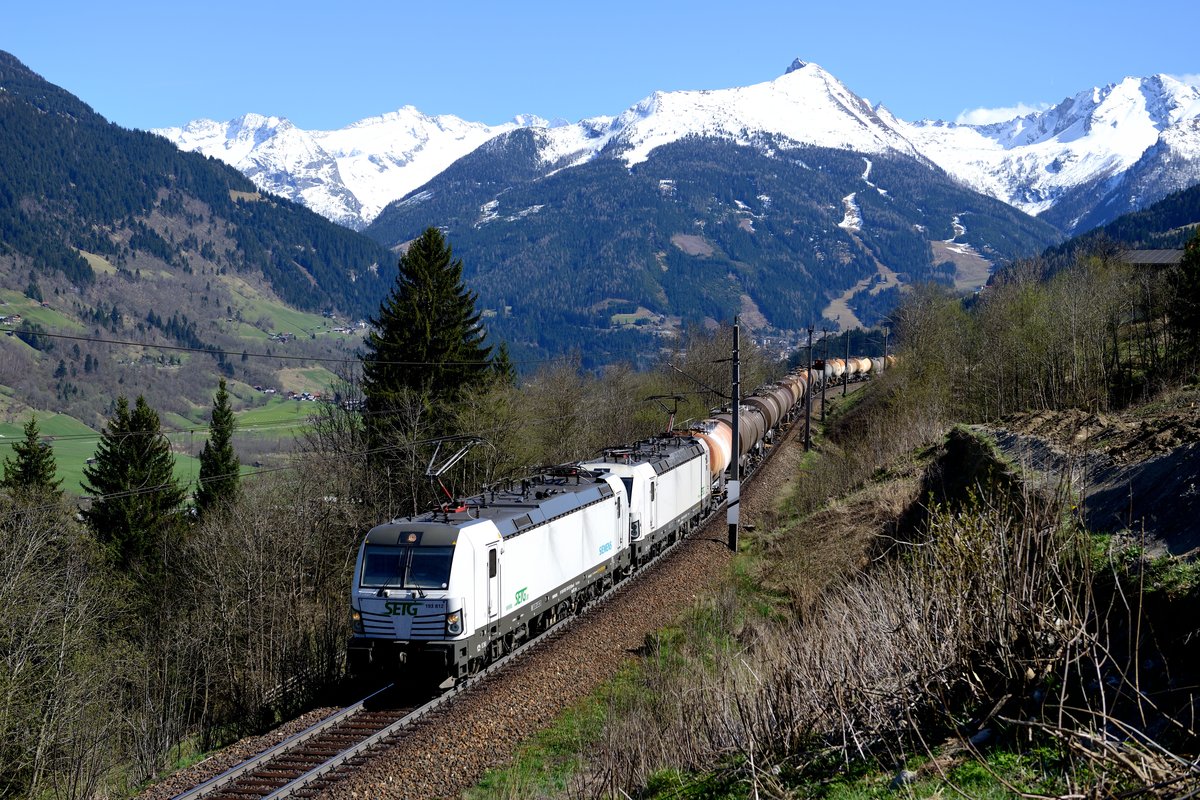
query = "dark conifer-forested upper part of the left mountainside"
xmin=0 ymin=48 xmax=390 ymax=313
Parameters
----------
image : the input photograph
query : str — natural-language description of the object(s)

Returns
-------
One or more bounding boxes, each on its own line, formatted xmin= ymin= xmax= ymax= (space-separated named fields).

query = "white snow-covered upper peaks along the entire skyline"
xmin=156 ymin=60 xmax=1200 ymax=233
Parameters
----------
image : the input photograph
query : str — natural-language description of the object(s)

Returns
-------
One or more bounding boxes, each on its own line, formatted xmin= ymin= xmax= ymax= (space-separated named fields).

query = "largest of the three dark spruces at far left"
xmin=83 ymin=396 xmax=186 ymax=572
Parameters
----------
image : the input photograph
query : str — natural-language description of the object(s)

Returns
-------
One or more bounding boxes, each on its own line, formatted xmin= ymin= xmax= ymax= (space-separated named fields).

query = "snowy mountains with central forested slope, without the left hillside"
xmin=150 ymin=60 xmax=1200 ymax=365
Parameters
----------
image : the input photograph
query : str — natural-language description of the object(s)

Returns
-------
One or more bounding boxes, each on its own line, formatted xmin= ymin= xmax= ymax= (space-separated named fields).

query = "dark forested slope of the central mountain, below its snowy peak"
xmin=366 ymin=135 xmax=1057 ymax=361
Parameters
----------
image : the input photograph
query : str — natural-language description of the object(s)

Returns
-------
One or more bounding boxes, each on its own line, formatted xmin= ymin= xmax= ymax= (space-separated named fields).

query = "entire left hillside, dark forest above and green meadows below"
xmin=0 ymin=53 xmax=395 ymax=438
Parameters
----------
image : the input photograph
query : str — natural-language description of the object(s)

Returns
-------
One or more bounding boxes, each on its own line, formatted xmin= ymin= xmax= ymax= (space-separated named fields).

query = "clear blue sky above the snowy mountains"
xmin=0 ymin=0 xmax=1200 ymax=130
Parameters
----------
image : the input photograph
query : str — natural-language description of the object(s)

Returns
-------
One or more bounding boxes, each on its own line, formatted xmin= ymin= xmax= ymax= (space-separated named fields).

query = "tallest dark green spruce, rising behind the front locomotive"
xmin=362 ymin=228 xmax=491 ymax=435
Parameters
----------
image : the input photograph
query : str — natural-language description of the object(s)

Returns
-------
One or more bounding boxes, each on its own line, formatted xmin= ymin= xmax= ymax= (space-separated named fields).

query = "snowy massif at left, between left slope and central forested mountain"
xmin=154 ymin=106 xmax=548 ymax=229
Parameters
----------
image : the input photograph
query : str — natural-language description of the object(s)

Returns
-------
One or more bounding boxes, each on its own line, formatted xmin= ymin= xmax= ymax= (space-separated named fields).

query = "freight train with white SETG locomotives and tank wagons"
xmin=347 ymin=359 xmax=883 ymax=682
